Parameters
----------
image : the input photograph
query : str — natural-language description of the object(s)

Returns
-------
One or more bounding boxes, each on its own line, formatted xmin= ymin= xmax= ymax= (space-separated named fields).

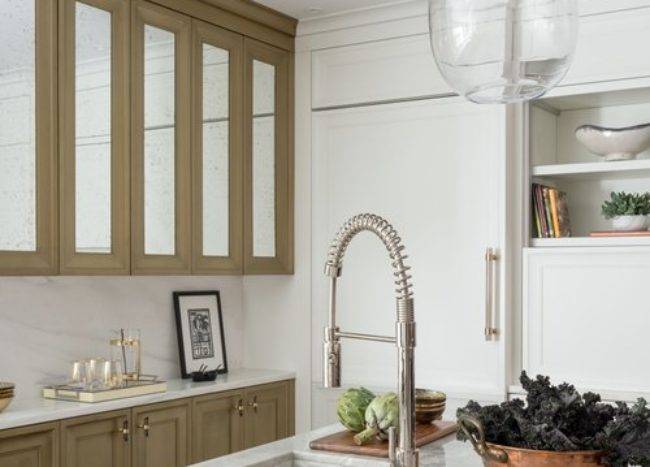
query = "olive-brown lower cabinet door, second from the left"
xmin=60 ymin=410 xmax=131 ymax=467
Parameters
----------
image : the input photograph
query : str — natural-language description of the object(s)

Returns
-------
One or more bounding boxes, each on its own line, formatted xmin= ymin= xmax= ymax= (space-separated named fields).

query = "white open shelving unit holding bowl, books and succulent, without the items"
xmin=527 ymin=88 xmax=650 ymax=248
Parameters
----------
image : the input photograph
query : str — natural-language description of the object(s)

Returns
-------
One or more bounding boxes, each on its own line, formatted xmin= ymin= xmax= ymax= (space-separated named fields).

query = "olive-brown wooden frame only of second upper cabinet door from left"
xmin=59 ymin=0 xmax=130 ymax=274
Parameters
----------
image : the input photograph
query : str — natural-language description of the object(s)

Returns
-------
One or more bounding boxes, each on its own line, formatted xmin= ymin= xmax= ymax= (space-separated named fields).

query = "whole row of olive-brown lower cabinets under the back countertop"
xmin=0 ymin=380 xmax=295 ymax=467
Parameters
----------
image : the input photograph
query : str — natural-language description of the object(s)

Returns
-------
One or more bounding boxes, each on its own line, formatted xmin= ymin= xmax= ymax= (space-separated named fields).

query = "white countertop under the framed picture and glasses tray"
xmin=0 ymin=369 xmax=296 ymax=430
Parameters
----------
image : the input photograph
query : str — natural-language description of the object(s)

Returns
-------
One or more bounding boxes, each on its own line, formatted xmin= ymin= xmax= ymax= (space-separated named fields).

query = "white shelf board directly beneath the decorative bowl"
xmin=531 ymin=159 xmax=650 ymax=180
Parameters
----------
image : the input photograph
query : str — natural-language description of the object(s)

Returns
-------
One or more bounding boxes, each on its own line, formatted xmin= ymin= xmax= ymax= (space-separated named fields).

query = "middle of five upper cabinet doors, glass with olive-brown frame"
xmin=131 ymin=0 xmax=191 ymax=274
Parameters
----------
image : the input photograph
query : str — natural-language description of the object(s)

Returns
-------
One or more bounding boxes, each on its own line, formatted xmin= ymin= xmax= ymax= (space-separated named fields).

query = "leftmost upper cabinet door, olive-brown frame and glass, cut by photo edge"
xmin=0 ymin=0 xmax=58 ymax=274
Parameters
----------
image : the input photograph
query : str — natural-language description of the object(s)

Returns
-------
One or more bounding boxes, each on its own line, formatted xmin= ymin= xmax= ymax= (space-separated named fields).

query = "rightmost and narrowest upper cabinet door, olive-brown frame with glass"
xmin=244 ymin=38 xmax=294 ymax=274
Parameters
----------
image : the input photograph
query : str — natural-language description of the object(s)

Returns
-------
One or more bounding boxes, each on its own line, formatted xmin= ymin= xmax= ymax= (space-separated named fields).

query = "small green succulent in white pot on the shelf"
xmin=601 ymin=191 xmax=650 ymax=231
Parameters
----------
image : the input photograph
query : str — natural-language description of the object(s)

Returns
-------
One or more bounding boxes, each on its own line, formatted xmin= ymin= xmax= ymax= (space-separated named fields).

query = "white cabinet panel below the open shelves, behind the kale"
xmin=523 ymin=247 xmax=650 ymax=399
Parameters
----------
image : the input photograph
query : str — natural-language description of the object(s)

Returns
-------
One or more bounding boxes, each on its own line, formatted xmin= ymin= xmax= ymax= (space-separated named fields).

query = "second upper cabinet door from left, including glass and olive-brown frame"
xmin=59 ymin=0 xmax=130 ymax=274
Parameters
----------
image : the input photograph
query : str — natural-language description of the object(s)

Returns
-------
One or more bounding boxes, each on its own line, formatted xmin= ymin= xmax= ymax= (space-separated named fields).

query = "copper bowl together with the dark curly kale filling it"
xmin=456 ymin=372 xmax=650 ymax=467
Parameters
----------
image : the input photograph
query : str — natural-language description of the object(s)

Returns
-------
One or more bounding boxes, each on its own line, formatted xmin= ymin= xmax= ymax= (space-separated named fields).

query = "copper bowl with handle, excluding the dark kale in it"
xmin=458 ymin=415 xmax=609 ymax=467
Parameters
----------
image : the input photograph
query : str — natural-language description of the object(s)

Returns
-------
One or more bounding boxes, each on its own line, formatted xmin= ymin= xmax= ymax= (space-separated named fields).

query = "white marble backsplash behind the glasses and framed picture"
xmin=0 ymin=276 xmax=244 ymax=399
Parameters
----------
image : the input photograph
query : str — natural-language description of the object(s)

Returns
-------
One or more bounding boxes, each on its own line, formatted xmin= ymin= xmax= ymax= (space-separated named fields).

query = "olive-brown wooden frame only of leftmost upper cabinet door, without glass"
xmin=0 ymin=0 xmax=59 ymax=275
